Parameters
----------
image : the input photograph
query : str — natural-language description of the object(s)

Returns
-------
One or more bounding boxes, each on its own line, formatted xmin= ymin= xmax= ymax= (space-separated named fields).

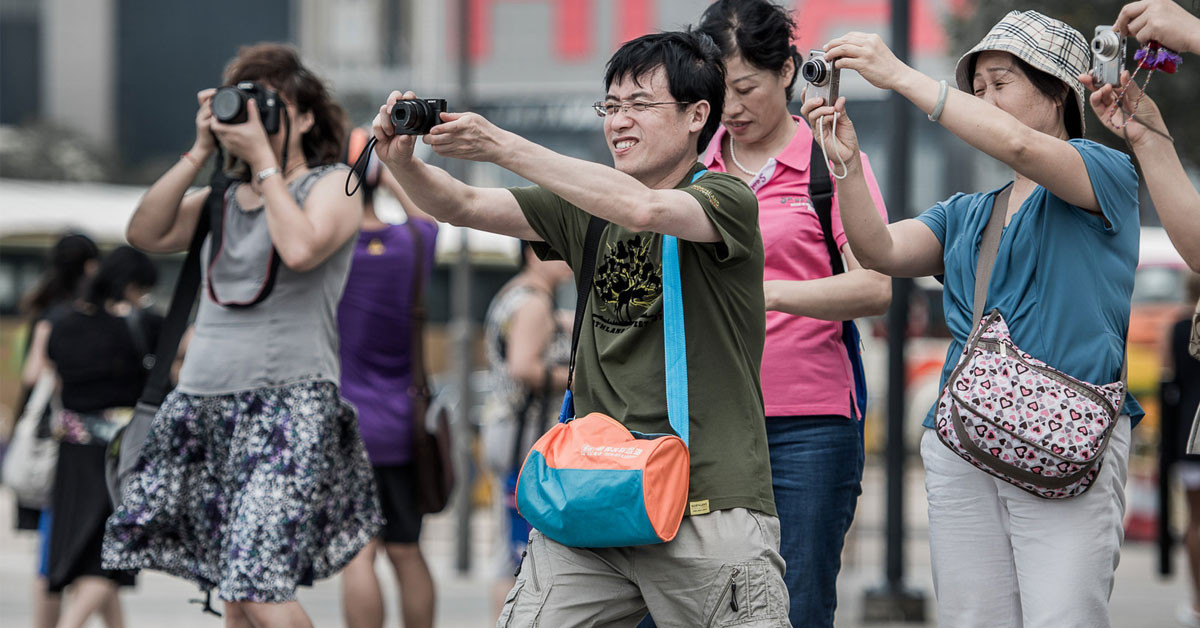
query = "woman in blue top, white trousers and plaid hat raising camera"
xmin=803 ymin=11 xmax=1142 ymax=628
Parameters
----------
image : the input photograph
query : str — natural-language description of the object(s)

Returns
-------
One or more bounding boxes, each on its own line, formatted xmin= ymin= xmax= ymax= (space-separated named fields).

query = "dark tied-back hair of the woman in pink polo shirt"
xmin=700 ymin=0 xmax=802 ymax=101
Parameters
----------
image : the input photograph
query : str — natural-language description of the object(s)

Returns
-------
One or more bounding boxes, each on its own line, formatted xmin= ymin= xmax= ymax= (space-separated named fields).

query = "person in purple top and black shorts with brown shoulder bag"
xmin=337 ymin=128 xmax=438 ymax=628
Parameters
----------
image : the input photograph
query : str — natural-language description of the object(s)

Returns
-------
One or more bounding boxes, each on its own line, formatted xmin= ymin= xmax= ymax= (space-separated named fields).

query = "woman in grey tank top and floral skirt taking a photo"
xmin=103 ymin=44 xmax=380 ymax=627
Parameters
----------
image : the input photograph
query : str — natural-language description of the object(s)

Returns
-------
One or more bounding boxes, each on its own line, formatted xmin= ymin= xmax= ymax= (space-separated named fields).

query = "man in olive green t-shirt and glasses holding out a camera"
xmin=374 ymin=32 xmax=787 ymax=627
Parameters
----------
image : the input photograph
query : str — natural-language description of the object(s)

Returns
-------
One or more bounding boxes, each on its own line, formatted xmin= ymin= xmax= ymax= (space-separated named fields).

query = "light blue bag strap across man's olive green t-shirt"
xmin=662 ymin=171 xmax=708 ymax=447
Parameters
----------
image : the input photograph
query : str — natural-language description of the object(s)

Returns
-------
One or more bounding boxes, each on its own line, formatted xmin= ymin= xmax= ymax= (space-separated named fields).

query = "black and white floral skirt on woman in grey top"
xmin=103 ymin=382 xmax=382 ymax=603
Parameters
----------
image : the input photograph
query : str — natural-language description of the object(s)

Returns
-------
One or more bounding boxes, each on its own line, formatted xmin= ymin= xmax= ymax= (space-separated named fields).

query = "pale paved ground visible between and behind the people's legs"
xmin=0 ymin=467 xmax=1187 ymax=628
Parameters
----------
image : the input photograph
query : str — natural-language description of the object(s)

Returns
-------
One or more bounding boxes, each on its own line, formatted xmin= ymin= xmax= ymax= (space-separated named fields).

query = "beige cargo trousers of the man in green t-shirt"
xmin=496 ymin=508 xmax=790 ymax=628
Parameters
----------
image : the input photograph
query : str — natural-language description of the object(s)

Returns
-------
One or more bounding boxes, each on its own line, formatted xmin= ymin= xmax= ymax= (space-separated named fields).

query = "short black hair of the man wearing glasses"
xmin=604 ymin=30 xmax=725 ymax=154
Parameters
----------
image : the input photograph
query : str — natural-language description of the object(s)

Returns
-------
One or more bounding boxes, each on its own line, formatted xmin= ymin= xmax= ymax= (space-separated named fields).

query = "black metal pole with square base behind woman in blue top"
xmin=863 ymin=0 xmax=925 ymax=622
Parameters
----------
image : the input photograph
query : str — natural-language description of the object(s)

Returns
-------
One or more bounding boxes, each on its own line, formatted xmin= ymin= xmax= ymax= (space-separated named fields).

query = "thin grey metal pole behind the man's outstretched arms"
xmin=448 ymin=0 xmax=474 ymax=574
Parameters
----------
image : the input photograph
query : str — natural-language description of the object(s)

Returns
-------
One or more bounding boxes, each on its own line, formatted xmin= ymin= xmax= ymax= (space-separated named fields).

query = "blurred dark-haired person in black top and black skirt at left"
xmin=47 ymin=246 xmax=162 ymax=627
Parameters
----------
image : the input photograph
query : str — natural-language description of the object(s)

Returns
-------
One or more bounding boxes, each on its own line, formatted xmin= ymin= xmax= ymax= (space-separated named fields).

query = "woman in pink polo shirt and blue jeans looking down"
xmin=700 ymin=0 xmax=892 ymax=626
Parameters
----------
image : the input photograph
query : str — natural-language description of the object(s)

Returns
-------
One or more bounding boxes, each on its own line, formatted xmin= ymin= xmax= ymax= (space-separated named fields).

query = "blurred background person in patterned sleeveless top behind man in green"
xmin=481 ymin=241 xmax=571 ymax=615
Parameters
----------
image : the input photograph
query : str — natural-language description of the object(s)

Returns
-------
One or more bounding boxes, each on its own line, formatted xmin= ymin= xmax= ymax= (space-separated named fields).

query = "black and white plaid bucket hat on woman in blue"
xmin=954 ymin=11 xmax=1092 ymax=131
